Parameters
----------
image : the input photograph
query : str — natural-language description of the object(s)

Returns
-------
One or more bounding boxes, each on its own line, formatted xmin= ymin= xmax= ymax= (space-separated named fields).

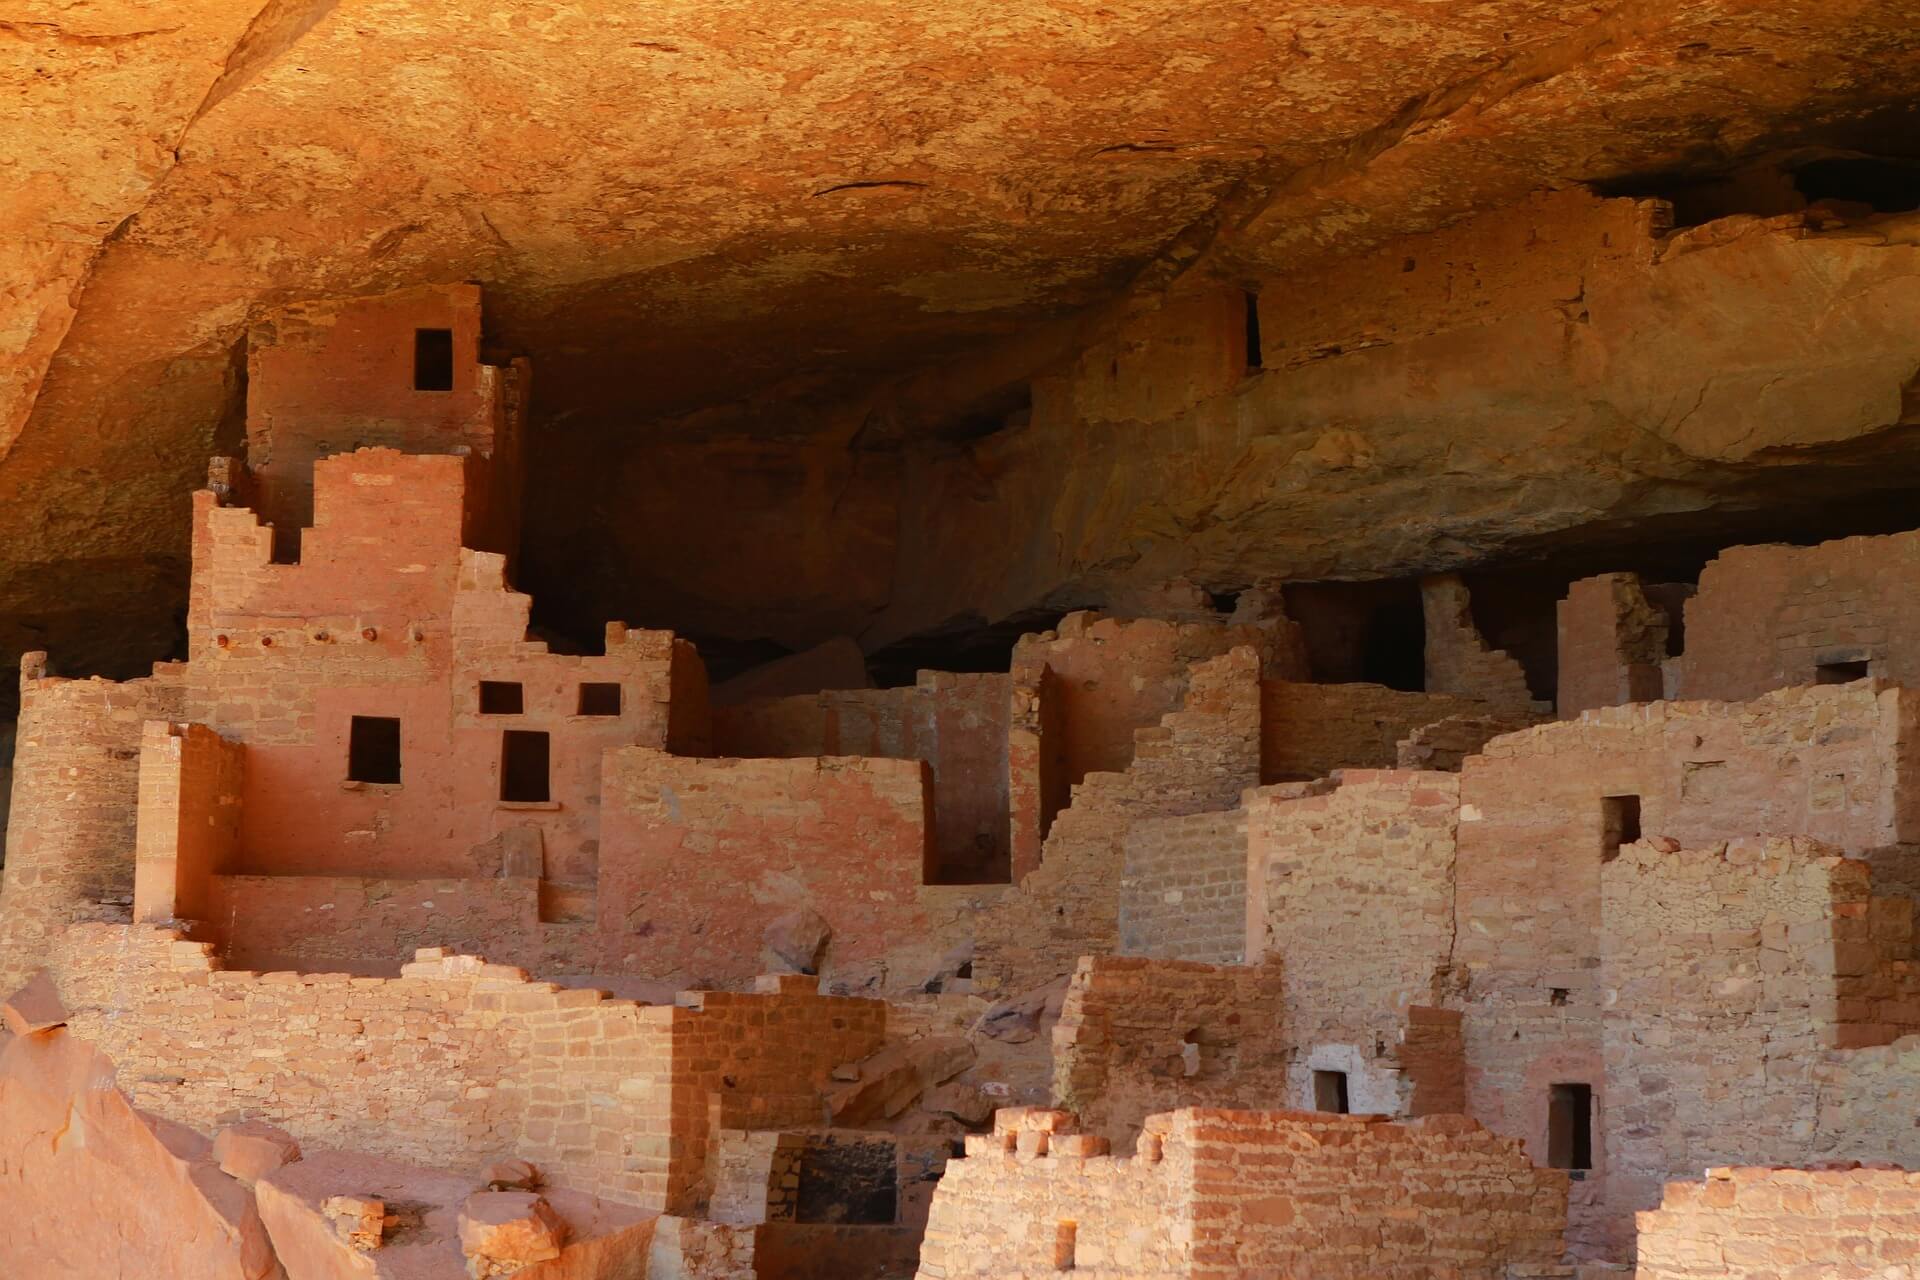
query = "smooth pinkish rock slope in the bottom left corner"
xmin=0 ymin=1029 xmax=280 ymax=1280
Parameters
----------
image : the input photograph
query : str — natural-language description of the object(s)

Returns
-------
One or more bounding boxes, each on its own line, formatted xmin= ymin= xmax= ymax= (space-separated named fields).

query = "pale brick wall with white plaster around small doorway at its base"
xmin=1244 ymin=770 xmax=1461 ymax=1115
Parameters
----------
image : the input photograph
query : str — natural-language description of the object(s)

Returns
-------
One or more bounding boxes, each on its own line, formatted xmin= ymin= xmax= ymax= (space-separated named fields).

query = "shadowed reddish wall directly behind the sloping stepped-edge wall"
xmin=1010 ymin=612 xmax=1308 ymax=879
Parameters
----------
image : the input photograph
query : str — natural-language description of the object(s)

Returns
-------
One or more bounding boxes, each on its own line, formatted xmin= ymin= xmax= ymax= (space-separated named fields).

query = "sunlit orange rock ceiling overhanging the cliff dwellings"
xmin=0 ymin=0 xmax=1920 ymax=679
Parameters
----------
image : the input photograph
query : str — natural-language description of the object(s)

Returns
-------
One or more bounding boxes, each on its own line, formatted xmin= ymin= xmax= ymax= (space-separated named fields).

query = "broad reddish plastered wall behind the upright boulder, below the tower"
xmin=597 ymin=747 xmax=1010 ymax=988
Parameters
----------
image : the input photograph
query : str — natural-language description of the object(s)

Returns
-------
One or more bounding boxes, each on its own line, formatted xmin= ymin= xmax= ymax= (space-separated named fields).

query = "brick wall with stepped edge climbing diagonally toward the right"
xmin=973 ymin=645 xmax=1260 ymax=994
